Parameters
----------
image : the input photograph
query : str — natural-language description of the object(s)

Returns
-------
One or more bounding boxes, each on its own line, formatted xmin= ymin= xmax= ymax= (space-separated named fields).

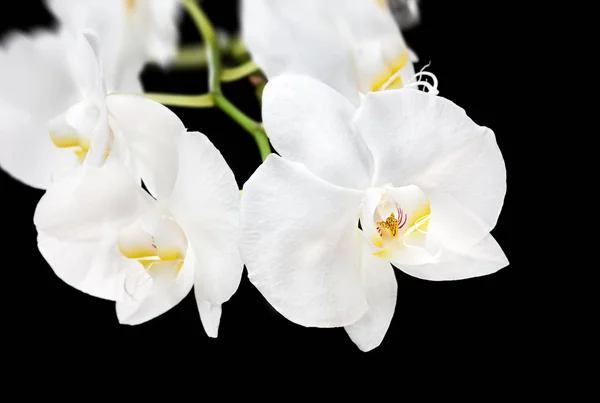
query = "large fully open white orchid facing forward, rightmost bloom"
xmin=241 ymin=75 xmax=508 ymax=351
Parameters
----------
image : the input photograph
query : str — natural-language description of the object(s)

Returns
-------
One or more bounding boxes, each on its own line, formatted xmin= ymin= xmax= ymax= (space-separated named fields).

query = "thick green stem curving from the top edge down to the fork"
xmin=182 ymin=0 xmax=221 ymax=94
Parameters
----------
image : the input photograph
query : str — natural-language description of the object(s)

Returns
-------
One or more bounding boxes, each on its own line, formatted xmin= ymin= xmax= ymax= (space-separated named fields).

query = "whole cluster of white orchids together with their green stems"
xmin=0 ymin=0 xmax=508 ymax=351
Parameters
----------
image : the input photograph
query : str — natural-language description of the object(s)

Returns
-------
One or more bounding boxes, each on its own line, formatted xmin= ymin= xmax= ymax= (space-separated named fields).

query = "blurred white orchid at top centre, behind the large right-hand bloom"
xmin=241 ymin=0 xmax=437 ymax=104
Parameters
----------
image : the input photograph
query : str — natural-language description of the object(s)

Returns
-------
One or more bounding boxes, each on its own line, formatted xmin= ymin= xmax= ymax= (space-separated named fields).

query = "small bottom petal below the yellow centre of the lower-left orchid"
xmin=116 ymin=252 xmax=195 ymax=325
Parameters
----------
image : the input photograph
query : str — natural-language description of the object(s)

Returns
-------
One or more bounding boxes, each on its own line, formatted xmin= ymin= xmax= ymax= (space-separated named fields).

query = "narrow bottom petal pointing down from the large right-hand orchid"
xmin=345 ymin=236 xmax=398 ymax=351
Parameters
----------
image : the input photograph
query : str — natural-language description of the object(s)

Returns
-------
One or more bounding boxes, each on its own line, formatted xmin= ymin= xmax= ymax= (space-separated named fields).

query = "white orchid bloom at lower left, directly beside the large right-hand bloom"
xmin=34 ymin=95 xmax=243 ymax=337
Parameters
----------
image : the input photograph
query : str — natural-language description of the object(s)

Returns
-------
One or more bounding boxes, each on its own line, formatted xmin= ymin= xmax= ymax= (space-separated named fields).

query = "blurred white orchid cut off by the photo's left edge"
xmin=0 ymin=30 xmax=114 ymax=189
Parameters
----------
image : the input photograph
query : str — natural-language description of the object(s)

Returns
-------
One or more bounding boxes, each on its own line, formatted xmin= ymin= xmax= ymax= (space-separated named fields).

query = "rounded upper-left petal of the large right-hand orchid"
xmin=262 ymin=75 xmax=370 ymax=188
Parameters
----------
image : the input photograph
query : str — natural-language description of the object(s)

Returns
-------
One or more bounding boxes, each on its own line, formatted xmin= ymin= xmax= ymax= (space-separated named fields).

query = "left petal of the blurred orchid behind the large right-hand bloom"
xmin=241 ymin=0 xmax=359 ymax=104
